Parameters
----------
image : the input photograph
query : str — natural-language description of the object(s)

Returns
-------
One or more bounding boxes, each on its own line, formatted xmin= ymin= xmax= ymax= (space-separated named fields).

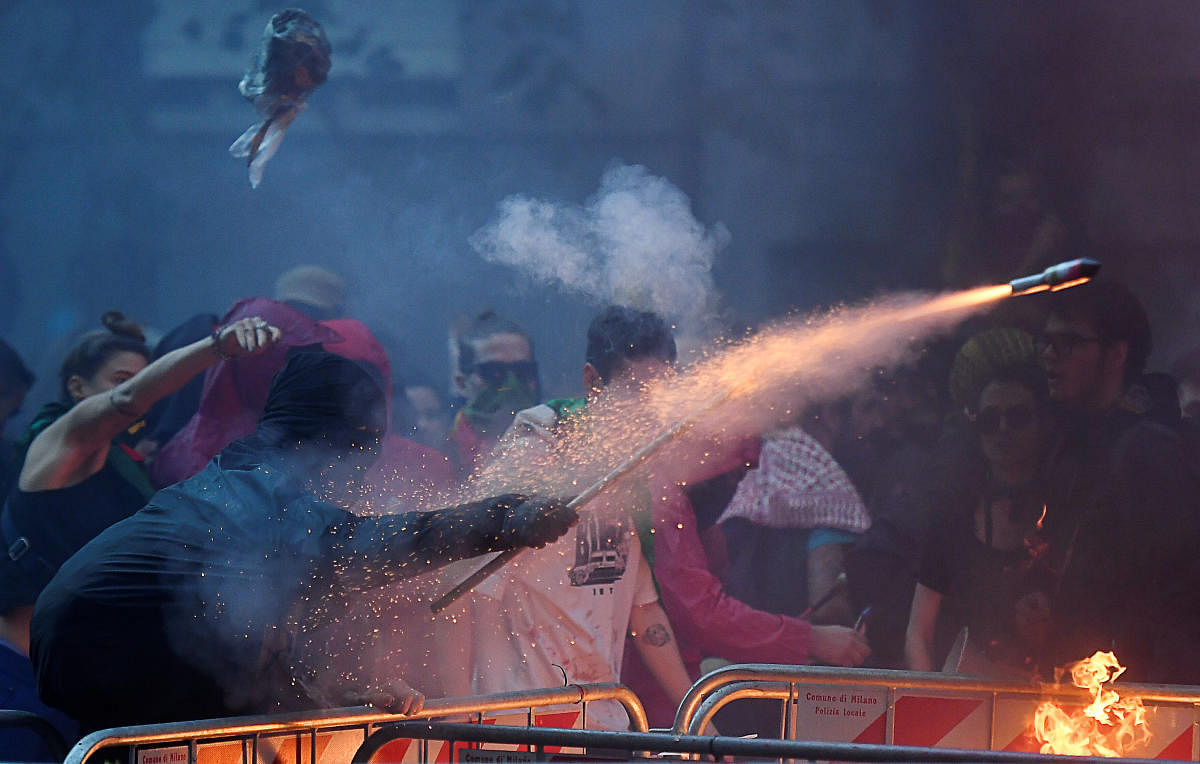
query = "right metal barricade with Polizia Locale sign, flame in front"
xmin=672 ymin=663 xmax=1200 ymax=762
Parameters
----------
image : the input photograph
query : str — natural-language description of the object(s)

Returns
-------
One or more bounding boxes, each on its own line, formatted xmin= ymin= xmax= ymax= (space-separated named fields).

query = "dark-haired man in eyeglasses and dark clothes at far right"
xmin=1037 ymin=281 xmax=1200 ymax=684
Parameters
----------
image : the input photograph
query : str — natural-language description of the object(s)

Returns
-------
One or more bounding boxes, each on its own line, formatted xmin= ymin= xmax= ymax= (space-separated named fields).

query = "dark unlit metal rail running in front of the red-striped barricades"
xmin=352 ymin=722 xmax=1176 ymax=764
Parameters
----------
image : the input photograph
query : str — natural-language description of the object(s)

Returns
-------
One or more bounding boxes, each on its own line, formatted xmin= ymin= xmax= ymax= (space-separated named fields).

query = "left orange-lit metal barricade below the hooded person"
xmin=65 ymin=684 xmax=647 ymax=764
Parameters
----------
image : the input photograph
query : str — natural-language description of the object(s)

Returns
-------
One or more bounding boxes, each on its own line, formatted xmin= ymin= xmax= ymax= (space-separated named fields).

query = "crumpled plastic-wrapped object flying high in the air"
xmin=229 ymin=8 xmax=332 ymax=188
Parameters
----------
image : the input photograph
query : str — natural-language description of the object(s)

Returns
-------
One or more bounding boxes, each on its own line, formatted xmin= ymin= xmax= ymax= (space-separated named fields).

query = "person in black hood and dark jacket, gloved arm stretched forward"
xmin=31 ymin=351 xmax=576 ymax=730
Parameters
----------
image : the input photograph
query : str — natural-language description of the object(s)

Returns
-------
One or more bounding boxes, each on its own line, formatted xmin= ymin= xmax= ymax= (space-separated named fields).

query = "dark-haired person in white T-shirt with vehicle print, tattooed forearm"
xmin=437 ymin=306 xmax=692 ymax=729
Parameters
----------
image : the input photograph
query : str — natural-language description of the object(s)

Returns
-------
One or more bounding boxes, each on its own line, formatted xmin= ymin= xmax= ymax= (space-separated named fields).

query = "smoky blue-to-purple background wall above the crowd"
xmin=0 ymin=0 xmax=1200 ymax=431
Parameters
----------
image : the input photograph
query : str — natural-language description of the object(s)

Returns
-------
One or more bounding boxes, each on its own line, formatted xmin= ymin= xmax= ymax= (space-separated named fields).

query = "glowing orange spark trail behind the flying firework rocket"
xmin=429 ymin=284 xmax=1012 ymax=604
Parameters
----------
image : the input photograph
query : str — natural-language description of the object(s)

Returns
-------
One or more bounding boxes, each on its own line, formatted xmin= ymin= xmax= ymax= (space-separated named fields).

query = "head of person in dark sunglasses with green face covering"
xmin=450 ymin=308 xmax=541 ymax=477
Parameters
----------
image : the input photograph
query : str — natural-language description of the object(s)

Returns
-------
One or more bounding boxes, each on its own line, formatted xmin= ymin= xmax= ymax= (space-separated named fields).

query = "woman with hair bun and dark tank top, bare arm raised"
xmin=0 ymin=311 xmax=280 ymax=655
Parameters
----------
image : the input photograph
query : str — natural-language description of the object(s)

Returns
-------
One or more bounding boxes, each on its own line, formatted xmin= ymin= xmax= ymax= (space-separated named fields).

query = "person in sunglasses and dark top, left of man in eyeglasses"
xmin=905 ymin=329 xmax=1054 ymax=679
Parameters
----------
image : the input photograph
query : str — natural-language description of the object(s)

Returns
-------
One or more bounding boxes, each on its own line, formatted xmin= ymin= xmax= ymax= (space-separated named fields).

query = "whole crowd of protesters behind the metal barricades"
xmin=0 ymin=260 xmax=1200 ymax=758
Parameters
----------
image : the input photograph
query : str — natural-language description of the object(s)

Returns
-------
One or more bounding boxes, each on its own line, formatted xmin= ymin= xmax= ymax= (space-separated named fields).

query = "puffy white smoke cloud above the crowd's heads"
xmin=469 ymin=164 xmax=730 ymax=329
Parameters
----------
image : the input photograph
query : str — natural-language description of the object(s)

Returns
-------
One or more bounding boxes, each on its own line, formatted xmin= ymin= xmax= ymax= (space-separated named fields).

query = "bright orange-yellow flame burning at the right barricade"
xmin=1033 ymin=651 xmax=1150 ymax=757
